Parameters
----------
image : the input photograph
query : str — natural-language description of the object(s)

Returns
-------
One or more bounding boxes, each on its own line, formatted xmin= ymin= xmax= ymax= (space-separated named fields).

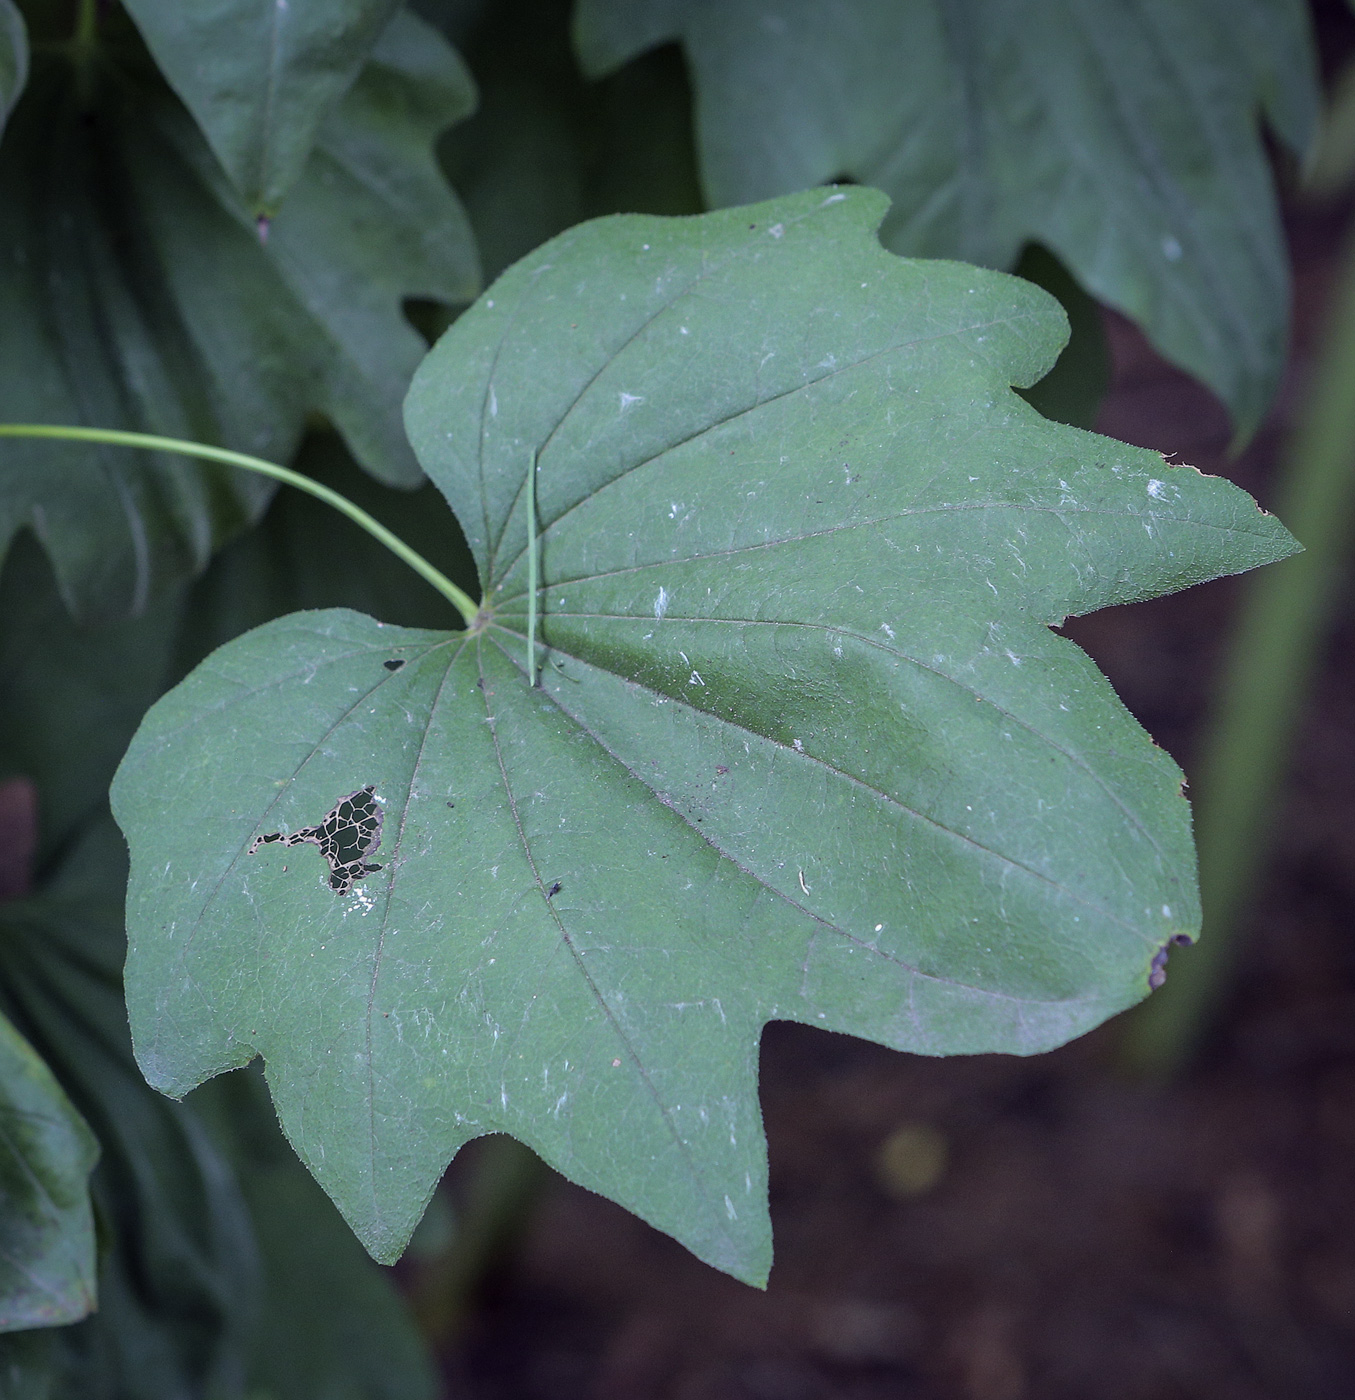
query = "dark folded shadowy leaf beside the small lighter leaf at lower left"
xmin=0 ymin=813 xmax=260 ymax=1400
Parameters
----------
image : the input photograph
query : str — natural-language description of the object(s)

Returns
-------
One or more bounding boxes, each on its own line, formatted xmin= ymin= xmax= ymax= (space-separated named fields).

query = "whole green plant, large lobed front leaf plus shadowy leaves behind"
xmin=0 ymin=0 xmax=1313 ymax=1396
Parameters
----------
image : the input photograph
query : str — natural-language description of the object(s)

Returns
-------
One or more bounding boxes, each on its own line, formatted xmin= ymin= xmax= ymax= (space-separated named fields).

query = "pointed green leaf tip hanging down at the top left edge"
xmin=126 ymin=0 xmax=399 ymax=216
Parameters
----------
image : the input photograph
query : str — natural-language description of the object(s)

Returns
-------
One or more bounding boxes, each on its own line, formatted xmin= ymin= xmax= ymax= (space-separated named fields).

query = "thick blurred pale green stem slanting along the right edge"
xmin=1121 ymin=221 xmax=1355 ymax=1078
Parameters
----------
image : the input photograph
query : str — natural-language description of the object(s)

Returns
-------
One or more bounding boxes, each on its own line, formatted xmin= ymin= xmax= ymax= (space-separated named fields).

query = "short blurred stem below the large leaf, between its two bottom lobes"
xmin=410 ymin=1135 xmax=547 ymax=1351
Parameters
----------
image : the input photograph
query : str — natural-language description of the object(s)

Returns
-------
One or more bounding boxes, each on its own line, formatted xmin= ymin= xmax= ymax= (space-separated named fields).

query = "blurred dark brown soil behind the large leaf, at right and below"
xmin=419 ymin=189 xmax=1355 ymax=1400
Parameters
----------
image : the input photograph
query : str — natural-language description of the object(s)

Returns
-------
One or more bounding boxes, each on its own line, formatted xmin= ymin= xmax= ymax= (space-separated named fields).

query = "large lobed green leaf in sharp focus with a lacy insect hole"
xmin=113 ymin=190 xmax=1293 ymax=1281
